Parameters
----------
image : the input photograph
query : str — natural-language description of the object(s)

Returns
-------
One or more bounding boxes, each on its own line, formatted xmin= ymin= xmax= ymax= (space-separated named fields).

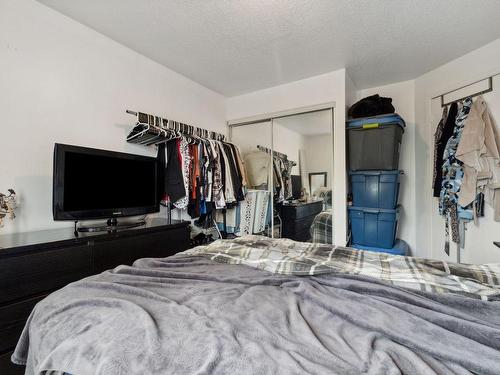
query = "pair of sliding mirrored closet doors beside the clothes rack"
xmin=227 ymin=105 xmax=334 ymax=243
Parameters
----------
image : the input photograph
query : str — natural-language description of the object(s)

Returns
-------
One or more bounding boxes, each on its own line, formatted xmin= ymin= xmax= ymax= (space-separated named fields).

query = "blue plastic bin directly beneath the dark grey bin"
xmin=349 ymin=170 xmax=402 ymax=209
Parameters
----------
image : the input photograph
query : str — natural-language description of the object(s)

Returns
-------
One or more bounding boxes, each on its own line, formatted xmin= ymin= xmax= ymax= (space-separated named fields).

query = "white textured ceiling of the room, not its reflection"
xmin=39 ymin=0 xmax=500 ymax=96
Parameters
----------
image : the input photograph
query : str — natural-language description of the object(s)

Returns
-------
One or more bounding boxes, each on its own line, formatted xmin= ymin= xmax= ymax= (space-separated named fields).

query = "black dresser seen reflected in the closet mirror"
xmin=280 ymin=200 xmax=323 ymax=241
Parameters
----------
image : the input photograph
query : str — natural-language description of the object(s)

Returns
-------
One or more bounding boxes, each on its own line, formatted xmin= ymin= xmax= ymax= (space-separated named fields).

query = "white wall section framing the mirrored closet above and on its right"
xmin=227 ymin=69 xmax=347 ymax=245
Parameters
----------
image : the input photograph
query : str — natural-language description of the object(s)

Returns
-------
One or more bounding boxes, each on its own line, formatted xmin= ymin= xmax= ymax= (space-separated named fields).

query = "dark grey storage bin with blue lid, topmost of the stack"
xmin=347 ymin=114 xmax=405 ymax=171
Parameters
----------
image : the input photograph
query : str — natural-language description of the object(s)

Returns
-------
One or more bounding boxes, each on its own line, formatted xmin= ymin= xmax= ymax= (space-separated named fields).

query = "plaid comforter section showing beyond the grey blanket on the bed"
xmin=184 ymin=235 xmax=500 ymax=300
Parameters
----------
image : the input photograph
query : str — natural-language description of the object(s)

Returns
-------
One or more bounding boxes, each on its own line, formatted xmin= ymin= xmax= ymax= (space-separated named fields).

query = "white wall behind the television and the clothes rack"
xmin=0 ymin=0 xmax=226 ymax=233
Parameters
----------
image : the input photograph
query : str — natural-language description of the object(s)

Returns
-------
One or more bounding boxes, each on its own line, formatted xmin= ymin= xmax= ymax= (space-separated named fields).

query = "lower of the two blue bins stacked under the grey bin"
xmin=348 ymin=207 xmax=400 ymax=249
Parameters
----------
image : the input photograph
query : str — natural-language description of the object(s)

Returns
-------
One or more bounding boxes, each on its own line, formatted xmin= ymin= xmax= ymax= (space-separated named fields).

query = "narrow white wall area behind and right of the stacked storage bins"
xmin=357 ymin=81 xmax=418 ymax=254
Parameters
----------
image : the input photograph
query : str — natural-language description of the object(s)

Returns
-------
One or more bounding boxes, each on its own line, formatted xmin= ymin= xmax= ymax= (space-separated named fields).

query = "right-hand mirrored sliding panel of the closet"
xmin=273 ymin=110 xmax=333 ymax=243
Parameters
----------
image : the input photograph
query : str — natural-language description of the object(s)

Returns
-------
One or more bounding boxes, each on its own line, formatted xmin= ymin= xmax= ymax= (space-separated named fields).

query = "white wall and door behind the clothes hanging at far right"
xmin=415 ymin=39 xmax=500 ymax=263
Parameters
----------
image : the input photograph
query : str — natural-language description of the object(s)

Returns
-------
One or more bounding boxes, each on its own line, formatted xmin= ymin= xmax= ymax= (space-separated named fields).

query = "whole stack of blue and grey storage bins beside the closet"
xmin=347 ymin=114 xmax=408 ymax=255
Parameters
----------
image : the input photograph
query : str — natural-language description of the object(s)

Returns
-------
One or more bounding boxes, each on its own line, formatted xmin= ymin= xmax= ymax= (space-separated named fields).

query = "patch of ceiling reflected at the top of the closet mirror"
xmin=274 ymin=110 xmax=332 ymax=136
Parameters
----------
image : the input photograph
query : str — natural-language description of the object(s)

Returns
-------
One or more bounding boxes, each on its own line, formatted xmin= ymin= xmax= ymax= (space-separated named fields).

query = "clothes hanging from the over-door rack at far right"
xmin=433 ymin=96 xmax=500 ymax=254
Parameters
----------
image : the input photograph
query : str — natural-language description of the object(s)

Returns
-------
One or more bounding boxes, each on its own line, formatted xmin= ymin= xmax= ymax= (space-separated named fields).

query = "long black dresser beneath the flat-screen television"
xmin=0 ymin=219 xmax=189 ymax=375
